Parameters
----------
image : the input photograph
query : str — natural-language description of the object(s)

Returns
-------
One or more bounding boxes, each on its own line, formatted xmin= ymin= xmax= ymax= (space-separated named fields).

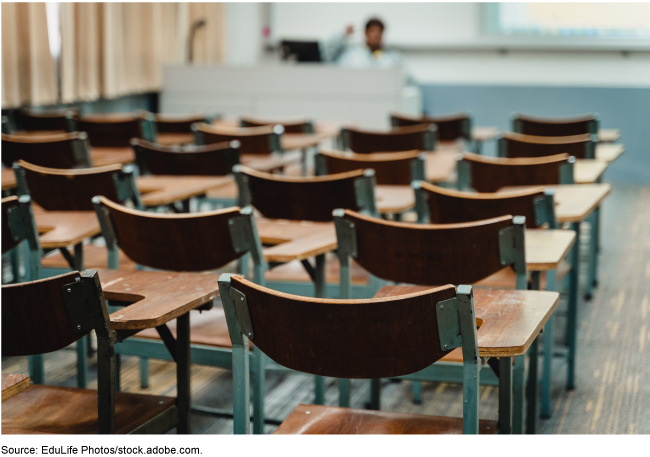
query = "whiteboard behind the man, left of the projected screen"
xmin=270 ymin=3 xmax=480 ymax=46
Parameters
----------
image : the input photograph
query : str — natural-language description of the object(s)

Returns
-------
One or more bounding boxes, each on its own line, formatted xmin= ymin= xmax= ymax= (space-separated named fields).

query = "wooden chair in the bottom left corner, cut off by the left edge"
xmin=2 ymin=270 xmax=190 ymax=434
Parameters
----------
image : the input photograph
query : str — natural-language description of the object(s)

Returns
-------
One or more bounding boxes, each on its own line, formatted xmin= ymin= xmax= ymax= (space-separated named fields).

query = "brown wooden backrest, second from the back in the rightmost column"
xmin=498 ymin=132 xmax=596 ymax=159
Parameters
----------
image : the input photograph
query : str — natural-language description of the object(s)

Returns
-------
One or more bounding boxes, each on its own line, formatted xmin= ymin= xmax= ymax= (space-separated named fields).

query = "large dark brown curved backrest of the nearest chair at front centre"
xmin=231 ymin=276 xmax=456 ymax=379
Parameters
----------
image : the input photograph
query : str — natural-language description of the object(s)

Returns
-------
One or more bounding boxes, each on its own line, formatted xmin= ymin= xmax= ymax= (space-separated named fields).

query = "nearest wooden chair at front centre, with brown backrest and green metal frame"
xmin=219 ymin=274 xmax=497 ymax=434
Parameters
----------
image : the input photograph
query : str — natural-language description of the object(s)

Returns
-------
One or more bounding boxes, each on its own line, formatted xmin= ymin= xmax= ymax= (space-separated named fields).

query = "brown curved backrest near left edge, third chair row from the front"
xmin=18 ymin=160 xmax=122 ymax=211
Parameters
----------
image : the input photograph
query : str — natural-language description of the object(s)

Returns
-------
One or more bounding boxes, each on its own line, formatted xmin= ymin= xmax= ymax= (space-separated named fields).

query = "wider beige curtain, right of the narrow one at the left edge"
xmin=60 ymin=3 xmax=224 ymax=103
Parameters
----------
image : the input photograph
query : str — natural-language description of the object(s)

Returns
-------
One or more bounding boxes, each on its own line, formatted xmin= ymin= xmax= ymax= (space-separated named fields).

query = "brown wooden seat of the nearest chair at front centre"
xmin=275 ymin=404 xmax=498 ymax=435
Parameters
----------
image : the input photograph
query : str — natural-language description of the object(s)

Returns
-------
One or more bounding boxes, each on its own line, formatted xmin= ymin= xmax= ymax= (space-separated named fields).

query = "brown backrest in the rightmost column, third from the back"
xmin=462 ymin=152 xmax=569 ymax=192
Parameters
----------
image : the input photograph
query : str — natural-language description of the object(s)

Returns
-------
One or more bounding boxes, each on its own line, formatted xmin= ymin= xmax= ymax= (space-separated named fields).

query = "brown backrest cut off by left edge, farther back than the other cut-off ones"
xmin=2 ymin=132 xmax=92 ymax=168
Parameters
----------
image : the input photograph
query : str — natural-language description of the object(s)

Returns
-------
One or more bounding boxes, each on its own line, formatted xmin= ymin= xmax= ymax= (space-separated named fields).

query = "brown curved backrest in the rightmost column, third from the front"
xmin=420 ymin=182 xmax=544 ymax=228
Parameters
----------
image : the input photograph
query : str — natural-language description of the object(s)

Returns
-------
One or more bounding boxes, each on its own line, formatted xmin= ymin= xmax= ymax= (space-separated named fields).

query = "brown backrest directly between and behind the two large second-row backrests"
xmin=233 ymin=165 xmax=376 ymax=222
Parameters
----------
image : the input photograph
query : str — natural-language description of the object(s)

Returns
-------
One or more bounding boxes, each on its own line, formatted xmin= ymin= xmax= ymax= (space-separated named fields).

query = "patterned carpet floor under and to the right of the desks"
xmin=2 ymin=186 xmax=650 ymax=434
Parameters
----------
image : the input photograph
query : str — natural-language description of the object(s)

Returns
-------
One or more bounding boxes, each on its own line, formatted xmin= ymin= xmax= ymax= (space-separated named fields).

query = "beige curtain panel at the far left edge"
xmin=2 ymin=2 xmax=58 ymax=109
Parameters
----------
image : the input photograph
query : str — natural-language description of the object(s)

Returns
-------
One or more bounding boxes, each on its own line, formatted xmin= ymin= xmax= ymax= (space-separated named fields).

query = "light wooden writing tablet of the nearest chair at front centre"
xmin=375 ymin=286 xmax=560 ymax=357
